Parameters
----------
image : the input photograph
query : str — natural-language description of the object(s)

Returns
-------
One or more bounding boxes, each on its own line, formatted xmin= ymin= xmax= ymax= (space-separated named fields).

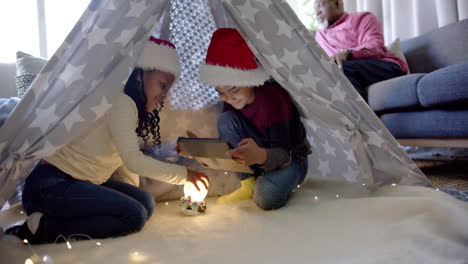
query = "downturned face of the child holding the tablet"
xmin=216 ymin=86 xmax=255 ymax=110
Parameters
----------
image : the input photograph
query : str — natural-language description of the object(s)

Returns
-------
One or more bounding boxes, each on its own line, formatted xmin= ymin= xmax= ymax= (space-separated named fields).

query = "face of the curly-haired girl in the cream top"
xmin=143 ymin=71 xmax=175 ymax=112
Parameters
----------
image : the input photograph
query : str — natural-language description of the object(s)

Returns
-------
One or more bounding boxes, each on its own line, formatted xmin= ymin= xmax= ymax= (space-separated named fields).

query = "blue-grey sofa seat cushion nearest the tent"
xmin=367 ymin=73 xmax=424 ymax=113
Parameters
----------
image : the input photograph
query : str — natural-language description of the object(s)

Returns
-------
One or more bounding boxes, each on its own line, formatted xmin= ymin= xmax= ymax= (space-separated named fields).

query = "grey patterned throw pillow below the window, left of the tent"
xmin=16 ymin=51 xmax=47 ymax=98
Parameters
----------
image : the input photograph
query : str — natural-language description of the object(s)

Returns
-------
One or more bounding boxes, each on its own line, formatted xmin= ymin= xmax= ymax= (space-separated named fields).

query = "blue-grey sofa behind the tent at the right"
xmin=367 ymin=19 xmax=468 ymax=148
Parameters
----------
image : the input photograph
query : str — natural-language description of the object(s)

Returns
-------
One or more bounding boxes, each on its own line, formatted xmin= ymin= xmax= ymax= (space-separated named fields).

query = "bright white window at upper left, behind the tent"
xmin=0 ymin=0 xmax=90 ymax=62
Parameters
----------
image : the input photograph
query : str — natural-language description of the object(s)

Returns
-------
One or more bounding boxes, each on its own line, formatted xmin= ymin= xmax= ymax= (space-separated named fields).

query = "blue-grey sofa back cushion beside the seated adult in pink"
xmin=401 ymin=19 xmax=468 ymax=73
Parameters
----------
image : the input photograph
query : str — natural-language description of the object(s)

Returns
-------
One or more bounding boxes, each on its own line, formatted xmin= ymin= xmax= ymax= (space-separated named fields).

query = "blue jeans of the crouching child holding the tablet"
xmin=218 ymin=111 xmax=308 ymax=210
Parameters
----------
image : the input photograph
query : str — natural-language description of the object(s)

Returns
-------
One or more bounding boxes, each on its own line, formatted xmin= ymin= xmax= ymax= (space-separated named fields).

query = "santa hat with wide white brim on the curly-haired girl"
xmin=136 ymin=36 xmax=180 ymax=78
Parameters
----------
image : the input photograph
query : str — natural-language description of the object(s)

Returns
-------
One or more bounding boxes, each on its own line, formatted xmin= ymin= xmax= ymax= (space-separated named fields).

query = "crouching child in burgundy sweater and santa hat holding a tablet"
xmin=200 ymin=28 xmax=311 ymax=210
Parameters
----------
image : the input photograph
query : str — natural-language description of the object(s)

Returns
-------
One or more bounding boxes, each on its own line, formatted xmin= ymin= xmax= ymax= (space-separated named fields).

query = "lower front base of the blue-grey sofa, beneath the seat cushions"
xmin=380 ymin=109 xmax=468 ymax=138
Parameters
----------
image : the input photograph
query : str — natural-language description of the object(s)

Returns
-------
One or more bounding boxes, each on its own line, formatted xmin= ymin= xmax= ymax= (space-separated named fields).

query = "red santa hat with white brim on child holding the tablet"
xmin=200 ymin=28 xmax=270 ymax=86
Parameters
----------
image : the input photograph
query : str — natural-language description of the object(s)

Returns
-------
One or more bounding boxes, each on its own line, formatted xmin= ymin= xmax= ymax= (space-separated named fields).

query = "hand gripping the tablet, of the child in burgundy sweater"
xmin=226 ymin=138 xmax=267 ymax=166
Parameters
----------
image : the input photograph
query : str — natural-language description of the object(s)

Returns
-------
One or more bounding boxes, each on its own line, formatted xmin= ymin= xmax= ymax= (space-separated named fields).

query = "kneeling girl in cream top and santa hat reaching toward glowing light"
xmin=6 ymin=37 xmax=208 ymax=243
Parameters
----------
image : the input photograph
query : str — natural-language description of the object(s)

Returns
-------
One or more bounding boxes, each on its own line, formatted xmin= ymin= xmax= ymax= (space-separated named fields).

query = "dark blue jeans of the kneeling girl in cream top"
xmin=23 ymin=164 xmax=155 ymax=243
